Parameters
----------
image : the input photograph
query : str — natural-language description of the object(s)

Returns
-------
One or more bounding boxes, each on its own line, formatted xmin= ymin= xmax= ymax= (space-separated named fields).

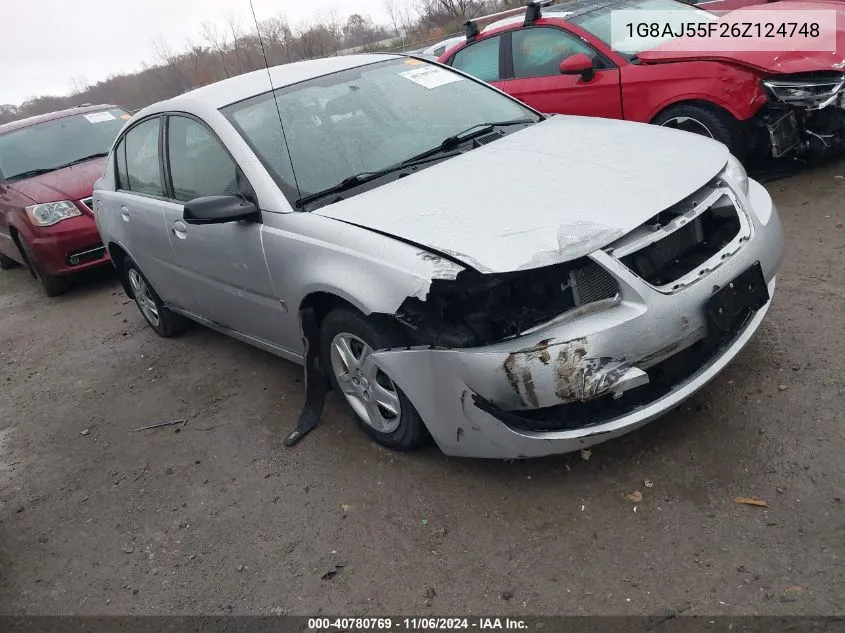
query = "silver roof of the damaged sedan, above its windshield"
xmin=139 ymin=54 xmax=402 ymax=119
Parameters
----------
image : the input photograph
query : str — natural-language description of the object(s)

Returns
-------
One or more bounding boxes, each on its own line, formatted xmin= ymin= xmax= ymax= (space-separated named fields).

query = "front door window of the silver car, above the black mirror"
xmin=167 ymin=116 xmax=238 ymax=202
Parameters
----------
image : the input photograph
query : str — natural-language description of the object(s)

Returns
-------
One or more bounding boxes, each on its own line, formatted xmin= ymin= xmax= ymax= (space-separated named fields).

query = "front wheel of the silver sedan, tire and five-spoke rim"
xmin=320 ymin=308 xmax=430 ymax=451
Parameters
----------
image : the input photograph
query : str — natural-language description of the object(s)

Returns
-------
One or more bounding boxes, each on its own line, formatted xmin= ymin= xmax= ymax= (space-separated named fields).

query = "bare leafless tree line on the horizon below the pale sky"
xmin=0 ymin=0 xmax=523 ymax=124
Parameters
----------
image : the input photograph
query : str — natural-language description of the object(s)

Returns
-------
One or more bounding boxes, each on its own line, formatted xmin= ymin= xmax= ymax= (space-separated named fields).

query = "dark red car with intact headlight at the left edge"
xmin=0 ymin=105 xmax=130 ymax=296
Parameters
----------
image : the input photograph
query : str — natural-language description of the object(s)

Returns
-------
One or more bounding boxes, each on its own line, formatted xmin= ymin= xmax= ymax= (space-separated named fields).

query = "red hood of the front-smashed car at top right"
xmin=637 ymin=0 xmax=845 ymax=73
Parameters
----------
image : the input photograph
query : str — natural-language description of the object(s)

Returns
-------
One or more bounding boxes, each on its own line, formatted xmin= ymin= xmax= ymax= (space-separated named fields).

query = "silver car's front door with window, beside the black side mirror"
xmin=165 ymin=114 xmax=282 ymax=344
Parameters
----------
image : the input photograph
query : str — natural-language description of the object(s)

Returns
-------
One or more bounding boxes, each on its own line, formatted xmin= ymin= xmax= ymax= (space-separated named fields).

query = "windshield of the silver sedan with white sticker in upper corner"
xmin=222 ymin=59 xmax=539 ymax=200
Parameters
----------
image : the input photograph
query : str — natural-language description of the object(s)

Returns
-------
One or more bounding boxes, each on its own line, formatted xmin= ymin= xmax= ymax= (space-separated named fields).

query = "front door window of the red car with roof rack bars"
xmin=513 ymin=27 xmax=601 ymax=79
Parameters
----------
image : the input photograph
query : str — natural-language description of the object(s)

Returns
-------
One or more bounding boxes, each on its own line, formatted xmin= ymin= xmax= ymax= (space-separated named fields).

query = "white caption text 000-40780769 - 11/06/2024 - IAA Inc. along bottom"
xmin=308 ymin=617 xmax=528 ymax=631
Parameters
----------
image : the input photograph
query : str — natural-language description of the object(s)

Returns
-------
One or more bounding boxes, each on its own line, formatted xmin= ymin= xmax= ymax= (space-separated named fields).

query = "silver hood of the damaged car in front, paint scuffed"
xmin=313 ymin=116 xmax=728 ymax=273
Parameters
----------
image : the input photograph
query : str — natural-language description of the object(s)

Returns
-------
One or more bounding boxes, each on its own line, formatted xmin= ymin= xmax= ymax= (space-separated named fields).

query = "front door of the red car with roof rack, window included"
xmin=499 ymin=26 xmax=622 ymax=119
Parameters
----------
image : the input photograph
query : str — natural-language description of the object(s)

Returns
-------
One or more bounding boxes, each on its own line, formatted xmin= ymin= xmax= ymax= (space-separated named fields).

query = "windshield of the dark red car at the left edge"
xmin=0 ymin=108 xmax=129 ymax=181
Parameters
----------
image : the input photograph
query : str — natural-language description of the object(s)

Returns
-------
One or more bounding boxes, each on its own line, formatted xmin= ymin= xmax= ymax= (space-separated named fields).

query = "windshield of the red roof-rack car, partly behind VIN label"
xmin=569 ymin=0 xmax=719 ymax=57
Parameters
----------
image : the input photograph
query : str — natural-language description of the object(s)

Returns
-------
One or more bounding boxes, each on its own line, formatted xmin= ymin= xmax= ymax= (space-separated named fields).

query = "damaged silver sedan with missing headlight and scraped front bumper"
xmin=94 ymin=55 xmax=783 ymax=458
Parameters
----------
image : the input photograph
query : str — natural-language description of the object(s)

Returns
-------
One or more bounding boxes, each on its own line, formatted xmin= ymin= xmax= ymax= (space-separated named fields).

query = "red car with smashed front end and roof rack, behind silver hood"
xmin=439 ymin=0 xmax=845 ymax=157
